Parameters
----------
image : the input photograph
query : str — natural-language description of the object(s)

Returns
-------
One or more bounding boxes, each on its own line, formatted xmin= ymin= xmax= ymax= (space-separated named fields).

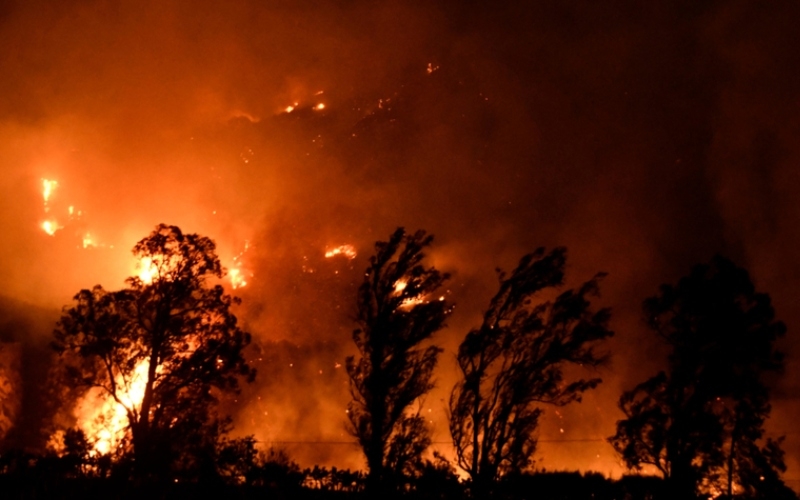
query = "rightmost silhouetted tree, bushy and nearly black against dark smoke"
xmin=610 ymin=256 xmax=785 ymax=498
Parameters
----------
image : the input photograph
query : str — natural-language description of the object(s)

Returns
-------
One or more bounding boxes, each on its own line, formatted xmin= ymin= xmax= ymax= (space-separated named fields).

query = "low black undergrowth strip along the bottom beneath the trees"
xmin=0 ymin=453 xmax=696 ymax=500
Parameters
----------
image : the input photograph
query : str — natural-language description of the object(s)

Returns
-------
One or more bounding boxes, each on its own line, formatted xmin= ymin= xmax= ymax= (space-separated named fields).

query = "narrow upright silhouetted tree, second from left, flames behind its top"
xmin=346 ymin=228 xmax=450 ymax=491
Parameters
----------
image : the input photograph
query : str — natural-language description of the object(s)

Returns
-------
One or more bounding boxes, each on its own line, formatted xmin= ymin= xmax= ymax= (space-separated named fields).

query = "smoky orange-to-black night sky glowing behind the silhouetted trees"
xmin=0 ymin=0 xmax=800 ymax=489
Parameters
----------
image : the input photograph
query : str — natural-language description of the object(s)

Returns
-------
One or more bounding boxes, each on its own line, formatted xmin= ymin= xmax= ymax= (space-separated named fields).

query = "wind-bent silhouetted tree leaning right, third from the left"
xmin=449 ymin=248 xmax=613 ymax=496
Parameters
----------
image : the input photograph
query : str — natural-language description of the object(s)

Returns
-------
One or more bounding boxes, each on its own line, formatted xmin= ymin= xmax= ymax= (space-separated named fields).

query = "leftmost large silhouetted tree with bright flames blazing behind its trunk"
xmin=53 ymin=224 xmax=255 ymax=477
